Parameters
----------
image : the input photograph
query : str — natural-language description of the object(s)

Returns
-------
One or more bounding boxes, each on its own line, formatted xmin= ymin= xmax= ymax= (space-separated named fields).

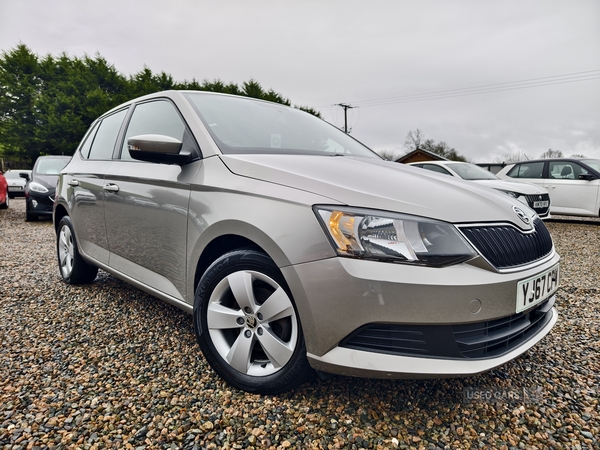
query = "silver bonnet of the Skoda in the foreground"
xmin=221 ymin=154 xmax=535 ymax=230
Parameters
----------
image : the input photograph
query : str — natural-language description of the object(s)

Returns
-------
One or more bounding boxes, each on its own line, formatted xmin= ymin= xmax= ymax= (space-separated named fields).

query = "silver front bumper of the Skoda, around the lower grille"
xmin=282 ymin=253 xmax=560 ymax=378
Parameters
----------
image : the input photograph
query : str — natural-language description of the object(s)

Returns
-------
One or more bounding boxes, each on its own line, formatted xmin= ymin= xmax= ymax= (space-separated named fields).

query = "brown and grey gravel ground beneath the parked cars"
xmin=0 ymin=199 xmax=600 ymax=449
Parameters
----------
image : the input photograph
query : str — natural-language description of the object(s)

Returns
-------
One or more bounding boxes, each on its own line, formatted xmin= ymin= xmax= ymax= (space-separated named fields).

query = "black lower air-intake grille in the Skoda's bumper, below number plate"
xmin=340 ymin=296 xmax=556 ymax=359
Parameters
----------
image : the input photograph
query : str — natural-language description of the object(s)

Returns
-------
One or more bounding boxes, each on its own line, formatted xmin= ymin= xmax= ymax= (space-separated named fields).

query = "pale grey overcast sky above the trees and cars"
xmin=0 ymin=0 xmax=600 ymax=162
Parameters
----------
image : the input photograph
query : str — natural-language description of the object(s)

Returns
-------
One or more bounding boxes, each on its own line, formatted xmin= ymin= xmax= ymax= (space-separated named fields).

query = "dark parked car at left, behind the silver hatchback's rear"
xmin=20 ymin=155 xmax=71 ymax=221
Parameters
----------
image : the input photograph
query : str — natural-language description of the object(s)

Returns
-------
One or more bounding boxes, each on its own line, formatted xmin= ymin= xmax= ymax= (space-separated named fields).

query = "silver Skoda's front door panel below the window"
xmin=104 ymin=161 xmax=190 ymax=299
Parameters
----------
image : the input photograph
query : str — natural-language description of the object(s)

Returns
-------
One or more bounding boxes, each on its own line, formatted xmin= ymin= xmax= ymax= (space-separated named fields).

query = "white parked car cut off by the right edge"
xmin=498 ymin=158 xmax=600 ymax=217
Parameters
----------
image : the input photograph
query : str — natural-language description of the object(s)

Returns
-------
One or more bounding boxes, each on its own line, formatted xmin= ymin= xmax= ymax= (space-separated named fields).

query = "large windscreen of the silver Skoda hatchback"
xmin=186 ymin=93 xmax=381 ymax=159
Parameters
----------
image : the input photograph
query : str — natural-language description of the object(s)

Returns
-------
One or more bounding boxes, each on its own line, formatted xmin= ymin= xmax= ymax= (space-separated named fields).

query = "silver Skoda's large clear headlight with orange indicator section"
xmin=314 ymin=206 xmax=477 ymax=267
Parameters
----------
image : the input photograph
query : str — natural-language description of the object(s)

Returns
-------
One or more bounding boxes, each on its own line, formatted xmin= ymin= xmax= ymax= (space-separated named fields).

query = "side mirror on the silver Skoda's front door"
xmin=127 ymin=134 xmax=191 ymax=165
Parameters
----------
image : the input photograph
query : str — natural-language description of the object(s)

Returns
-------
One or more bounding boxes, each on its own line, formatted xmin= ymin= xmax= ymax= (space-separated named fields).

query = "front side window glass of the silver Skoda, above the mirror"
xmin=121 ymin=100 xmax=185 ymax=160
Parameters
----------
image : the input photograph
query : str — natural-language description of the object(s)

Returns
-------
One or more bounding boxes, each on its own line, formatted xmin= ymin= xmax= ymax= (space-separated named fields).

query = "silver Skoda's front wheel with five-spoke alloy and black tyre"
xmin=194 ymin=250 xmax=312 ymax=395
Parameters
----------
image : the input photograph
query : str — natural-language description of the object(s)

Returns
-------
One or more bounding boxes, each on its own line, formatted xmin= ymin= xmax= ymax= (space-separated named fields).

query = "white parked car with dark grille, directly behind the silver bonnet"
xmin=409 ymin=161 xmax=550 ymax=219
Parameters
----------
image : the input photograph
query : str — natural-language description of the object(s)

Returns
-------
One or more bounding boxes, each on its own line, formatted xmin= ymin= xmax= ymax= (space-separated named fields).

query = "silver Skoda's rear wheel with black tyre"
xmin=56 ymin=216 xmax=98 ymax=284
